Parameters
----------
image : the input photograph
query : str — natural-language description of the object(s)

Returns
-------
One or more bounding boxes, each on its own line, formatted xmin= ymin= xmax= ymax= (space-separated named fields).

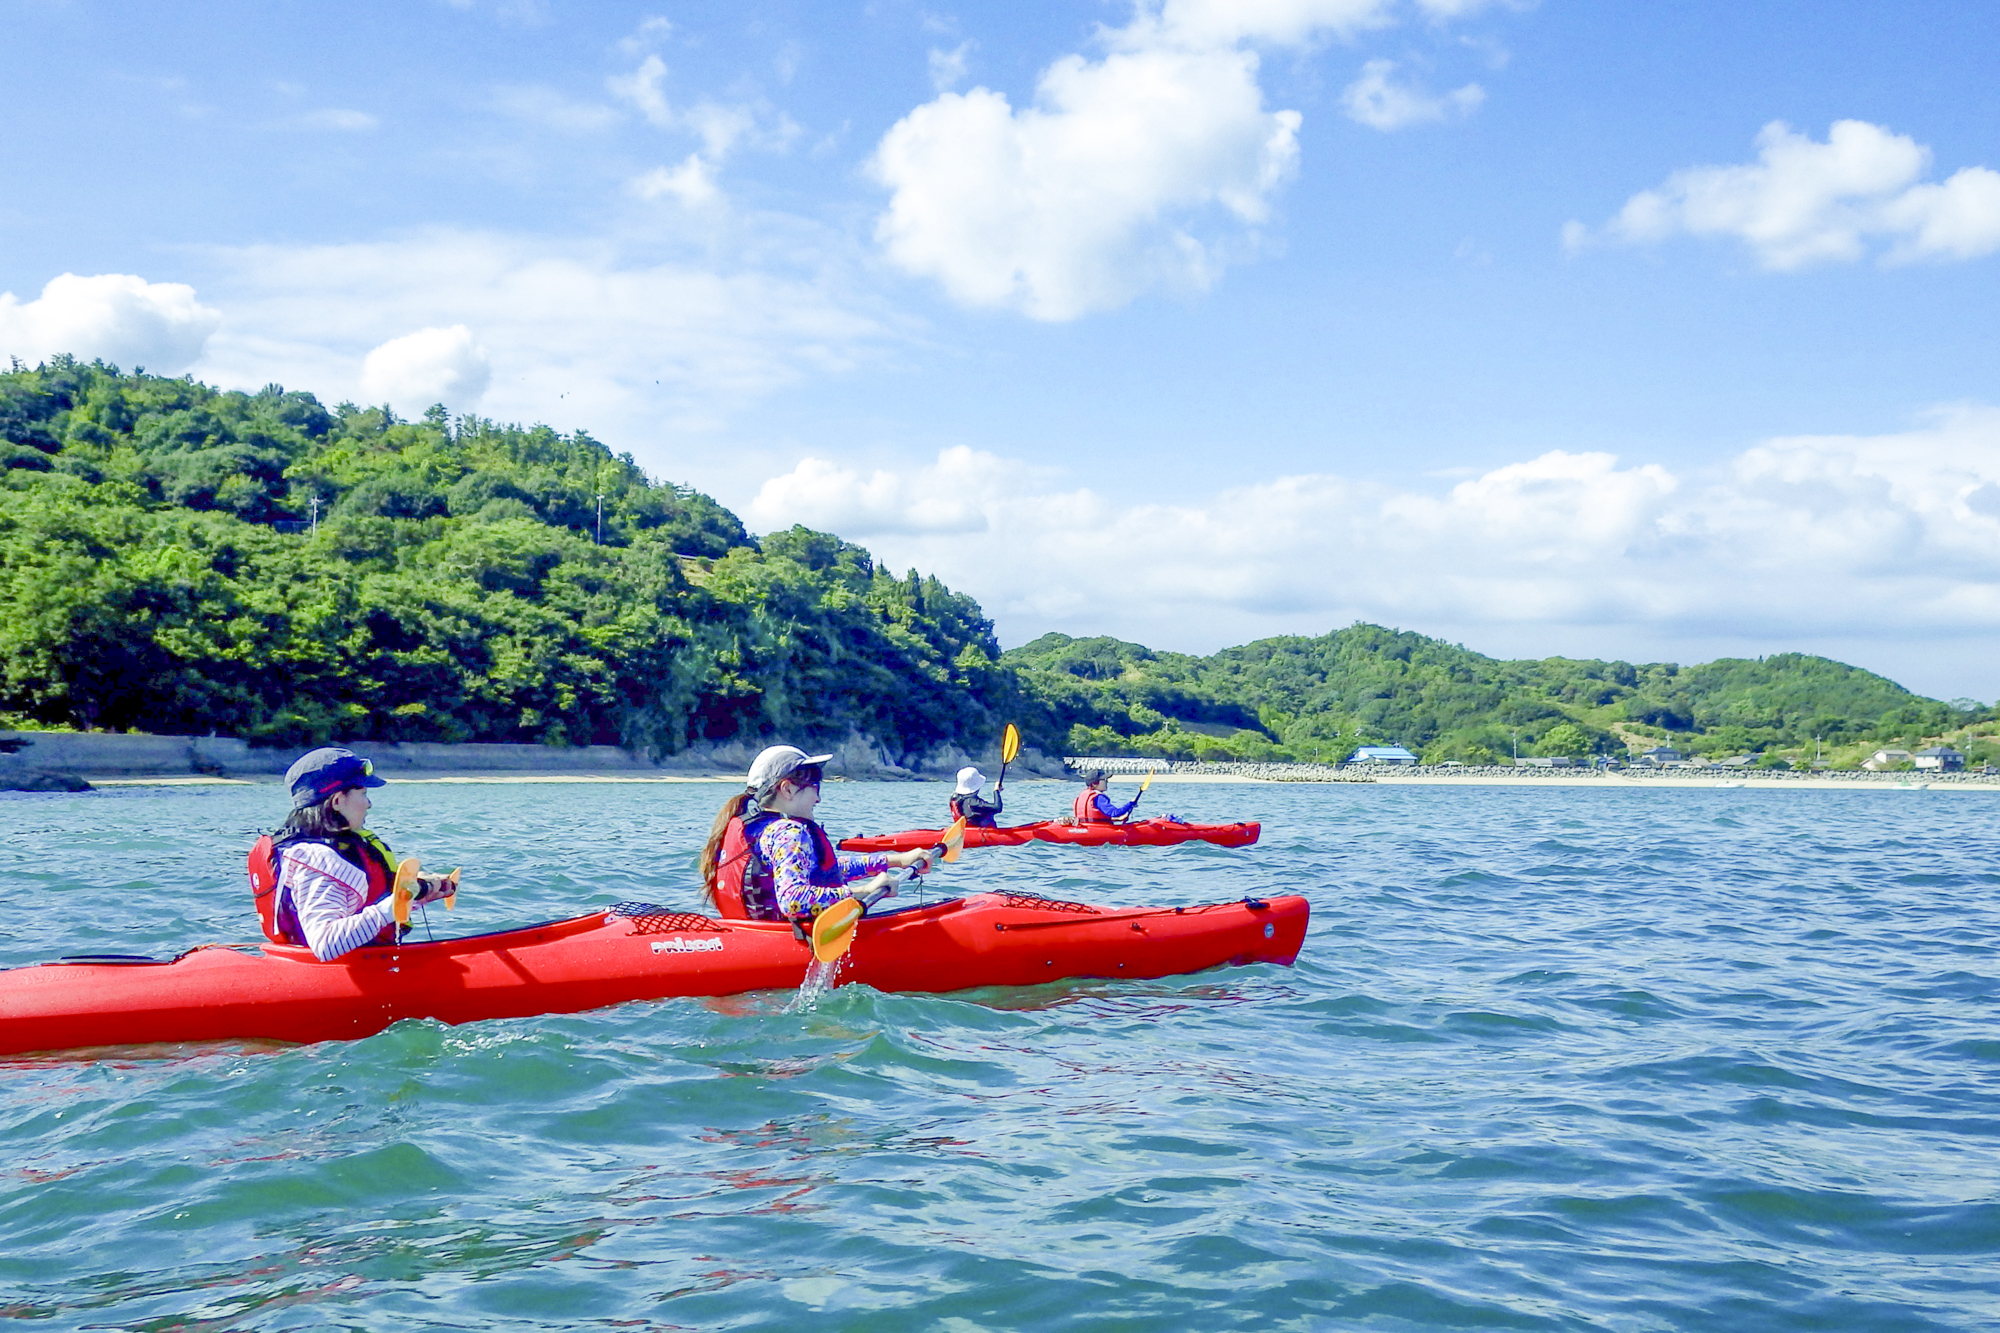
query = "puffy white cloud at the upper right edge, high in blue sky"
xmin=1564 ymin=120 xmax=2000 ymax=270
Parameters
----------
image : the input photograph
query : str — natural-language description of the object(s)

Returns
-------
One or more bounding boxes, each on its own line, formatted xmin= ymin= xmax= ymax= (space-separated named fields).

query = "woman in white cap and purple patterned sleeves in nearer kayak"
xmin=702 ymin=745 xmax=930 ymax=921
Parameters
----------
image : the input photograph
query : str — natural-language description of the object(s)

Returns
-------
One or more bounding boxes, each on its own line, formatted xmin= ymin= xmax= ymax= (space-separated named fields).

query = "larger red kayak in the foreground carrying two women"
xmin=0 ymin=893 xmax=1308 ymax=1055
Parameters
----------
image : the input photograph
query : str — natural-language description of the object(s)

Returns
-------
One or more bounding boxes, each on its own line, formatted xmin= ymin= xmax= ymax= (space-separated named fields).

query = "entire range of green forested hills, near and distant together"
xmin=0 ymin=358 xmax=1992 ymax=761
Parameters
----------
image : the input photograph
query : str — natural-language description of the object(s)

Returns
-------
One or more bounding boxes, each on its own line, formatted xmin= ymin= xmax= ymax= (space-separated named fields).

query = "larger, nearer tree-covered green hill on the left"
xmin=0 ymin=358 xmax=1016 ymax=753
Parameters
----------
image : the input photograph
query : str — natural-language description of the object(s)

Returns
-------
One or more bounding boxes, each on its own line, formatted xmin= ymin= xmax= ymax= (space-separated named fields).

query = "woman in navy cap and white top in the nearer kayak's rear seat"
xmin=250 ymin=747 xmax=448 ymax=963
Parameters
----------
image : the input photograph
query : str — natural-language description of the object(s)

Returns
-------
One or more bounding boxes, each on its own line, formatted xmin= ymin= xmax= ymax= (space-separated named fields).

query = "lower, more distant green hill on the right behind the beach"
xmin=1000 ymin=624 xmax=1990 ymax=763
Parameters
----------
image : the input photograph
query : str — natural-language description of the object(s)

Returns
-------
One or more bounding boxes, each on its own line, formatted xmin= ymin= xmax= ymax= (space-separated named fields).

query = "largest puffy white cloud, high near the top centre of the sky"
xmin=870 ymin=46 xmax=1300 ymax=320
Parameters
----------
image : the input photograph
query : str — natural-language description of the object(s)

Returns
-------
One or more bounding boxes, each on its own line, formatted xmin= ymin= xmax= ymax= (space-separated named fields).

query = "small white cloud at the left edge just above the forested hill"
xmin=0 ymin=272 xmax=222 ymax=374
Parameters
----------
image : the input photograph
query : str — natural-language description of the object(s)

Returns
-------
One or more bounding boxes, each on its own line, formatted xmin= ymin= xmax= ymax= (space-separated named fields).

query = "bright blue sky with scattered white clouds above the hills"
xmin=0 ymin=0 xmax=2000 ymax=701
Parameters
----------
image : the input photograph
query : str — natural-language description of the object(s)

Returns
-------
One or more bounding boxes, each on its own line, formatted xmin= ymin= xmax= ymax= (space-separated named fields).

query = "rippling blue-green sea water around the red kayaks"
xmin=0 ymin=783 xmax=2000 ymax=1333
